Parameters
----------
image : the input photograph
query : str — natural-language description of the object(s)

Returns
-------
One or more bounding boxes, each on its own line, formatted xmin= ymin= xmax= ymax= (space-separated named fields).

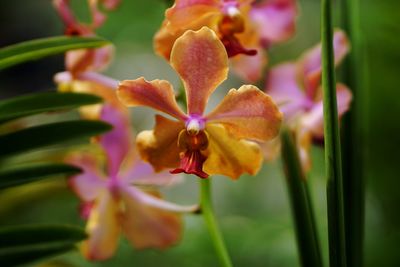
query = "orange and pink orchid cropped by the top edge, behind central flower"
xmin=154 ymin=0 xmax=297 ymax=82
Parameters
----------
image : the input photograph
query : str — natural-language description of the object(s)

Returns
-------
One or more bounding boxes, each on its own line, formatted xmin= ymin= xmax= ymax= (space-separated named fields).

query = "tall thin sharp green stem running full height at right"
xmin=321 ymin=0 xmax=347 ymax=267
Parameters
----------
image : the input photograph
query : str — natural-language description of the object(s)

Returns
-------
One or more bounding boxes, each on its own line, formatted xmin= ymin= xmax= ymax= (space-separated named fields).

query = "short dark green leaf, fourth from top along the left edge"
xmin=0 ymin=163 xmax=81 ymax=189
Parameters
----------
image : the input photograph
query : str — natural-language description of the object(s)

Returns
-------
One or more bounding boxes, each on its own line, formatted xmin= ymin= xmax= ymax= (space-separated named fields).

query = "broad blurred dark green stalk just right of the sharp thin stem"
xmin=342 ymin=0 xmax=367 ymax=267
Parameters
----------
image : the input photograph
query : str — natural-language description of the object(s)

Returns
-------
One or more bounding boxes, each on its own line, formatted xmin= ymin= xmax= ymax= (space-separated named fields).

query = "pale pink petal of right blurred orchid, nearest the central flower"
xmin=265 ymin=63 xmax=309 ymax=121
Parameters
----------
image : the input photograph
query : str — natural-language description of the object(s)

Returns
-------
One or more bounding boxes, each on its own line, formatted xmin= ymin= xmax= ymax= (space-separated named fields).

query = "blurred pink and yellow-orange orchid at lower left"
xmin=67 ymin=105 xmax=197 ymax=260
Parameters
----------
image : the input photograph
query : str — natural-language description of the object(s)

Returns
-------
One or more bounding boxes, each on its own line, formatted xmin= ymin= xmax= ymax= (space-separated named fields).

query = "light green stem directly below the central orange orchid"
xmin=200 ymin=178 xmax=233 ymax=267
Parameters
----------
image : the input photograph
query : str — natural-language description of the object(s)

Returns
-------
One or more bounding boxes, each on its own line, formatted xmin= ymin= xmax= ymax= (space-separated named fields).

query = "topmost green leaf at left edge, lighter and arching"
xmin=0 ymin=36 xmax=109 ymax=70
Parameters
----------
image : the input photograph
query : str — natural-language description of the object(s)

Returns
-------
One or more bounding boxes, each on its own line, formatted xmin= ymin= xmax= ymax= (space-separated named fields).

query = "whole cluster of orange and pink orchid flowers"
xmin=53 ymin=0 xmax=352 ymax=260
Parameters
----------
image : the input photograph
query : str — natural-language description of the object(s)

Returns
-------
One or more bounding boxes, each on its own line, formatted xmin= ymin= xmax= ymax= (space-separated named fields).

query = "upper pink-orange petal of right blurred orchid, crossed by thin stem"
xmin=298 ymin=30 xmax=350 ymax=99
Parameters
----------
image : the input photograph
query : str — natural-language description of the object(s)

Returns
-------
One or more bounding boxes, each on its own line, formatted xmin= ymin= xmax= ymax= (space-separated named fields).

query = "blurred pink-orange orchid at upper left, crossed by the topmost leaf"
xmin=53 ymin=0 xmax=124 ymax=119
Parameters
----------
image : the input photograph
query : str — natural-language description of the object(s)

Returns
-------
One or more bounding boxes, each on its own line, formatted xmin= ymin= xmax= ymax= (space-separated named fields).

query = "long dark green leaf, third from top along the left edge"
xmin=0 ymin=120 xmax=112 ymax=158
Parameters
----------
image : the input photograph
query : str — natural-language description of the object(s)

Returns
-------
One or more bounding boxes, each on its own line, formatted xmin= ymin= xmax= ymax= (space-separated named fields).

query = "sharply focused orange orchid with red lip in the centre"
xmin=117 ymin=27 xmax=282 ymax=179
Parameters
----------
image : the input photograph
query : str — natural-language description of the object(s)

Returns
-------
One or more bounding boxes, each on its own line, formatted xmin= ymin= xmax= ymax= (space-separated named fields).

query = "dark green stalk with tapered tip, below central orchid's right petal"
xmin=281 ymin=129 xmax=323 ymax=267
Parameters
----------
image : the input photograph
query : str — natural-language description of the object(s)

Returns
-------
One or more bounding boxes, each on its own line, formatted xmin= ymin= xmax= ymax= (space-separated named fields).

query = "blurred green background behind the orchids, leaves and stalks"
xmin=0 ymin=0 xmax=400 ymax=267
